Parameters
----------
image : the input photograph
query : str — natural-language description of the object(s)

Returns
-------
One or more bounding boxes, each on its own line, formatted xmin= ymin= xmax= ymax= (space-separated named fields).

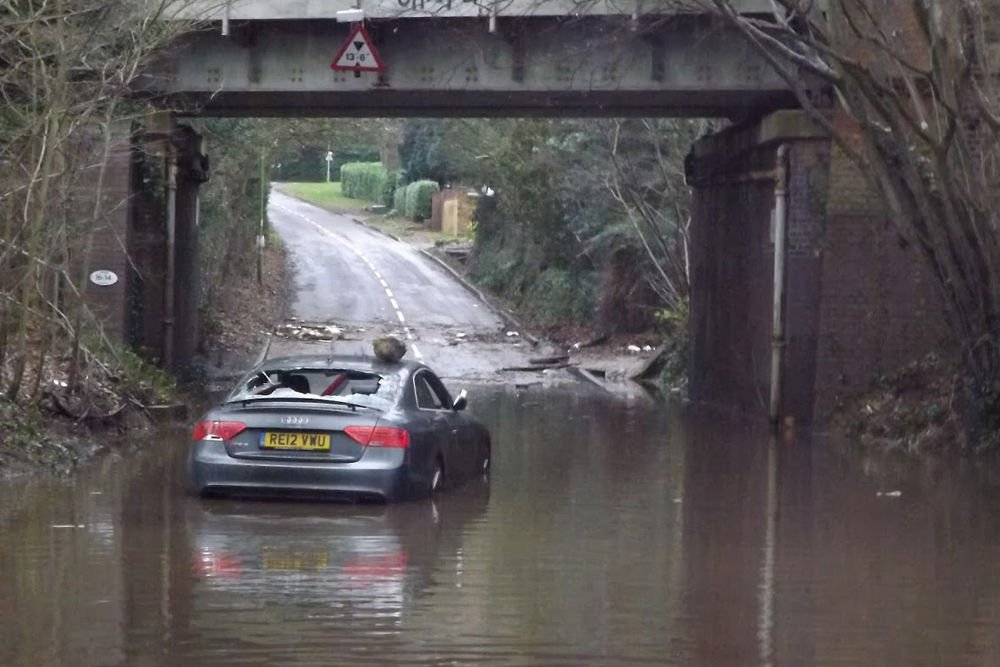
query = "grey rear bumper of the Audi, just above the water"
xmin=188 ymin=441 xmax=418 ymax=501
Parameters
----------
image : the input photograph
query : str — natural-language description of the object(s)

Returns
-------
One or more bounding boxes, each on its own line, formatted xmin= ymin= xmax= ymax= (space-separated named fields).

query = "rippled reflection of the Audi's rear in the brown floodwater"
xmin=187 ymin=480 xmax=489 ymax=630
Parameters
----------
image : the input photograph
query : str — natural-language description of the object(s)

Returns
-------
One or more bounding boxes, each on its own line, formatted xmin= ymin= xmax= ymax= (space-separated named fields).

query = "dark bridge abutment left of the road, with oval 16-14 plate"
xmin=86 ymin=114 xmax=207 ymax=370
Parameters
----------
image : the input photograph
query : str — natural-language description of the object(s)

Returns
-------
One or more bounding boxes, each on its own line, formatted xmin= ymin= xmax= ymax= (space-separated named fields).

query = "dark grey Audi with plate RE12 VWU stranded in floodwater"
xmin=188 ymin=356 xmax=491 ymax=502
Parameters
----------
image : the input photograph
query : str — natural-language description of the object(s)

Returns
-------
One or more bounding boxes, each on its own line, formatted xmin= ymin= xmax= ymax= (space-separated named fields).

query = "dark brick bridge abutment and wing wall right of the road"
xmin=688 ymin=111 xmax=951 ymax=423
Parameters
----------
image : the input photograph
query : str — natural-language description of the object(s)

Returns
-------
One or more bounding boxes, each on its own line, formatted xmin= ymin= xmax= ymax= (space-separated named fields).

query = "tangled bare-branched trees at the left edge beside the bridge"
xmin=0 ymin=0 xmax=197 ymax=400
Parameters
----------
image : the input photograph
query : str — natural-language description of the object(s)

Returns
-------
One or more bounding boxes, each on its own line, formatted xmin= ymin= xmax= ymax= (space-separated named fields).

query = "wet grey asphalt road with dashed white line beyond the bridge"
xmin=268 ymin=191 xmax=550 ymax=380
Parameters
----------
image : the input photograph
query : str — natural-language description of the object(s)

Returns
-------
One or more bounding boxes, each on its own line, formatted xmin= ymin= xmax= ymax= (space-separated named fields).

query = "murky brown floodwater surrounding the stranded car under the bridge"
xmin=0 ymin=387 xmax=1000 ymax=667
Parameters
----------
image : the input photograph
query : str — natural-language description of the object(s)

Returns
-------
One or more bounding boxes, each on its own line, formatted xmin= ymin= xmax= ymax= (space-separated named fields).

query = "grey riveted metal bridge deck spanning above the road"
xmin=148 ymin=0 xmax=796 ymax=118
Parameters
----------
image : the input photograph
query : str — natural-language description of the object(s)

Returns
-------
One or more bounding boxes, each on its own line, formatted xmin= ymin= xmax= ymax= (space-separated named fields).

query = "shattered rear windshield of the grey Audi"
xmin=228 ymin=367 xmax=400 ymax=410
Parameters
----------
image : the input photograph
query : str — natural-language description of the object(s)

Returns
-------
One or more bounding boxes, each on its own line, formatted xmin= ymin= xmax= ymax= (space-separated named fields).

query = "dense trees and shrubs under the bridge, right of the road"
xmin=404 ymin=119 xmax=709 ymax=331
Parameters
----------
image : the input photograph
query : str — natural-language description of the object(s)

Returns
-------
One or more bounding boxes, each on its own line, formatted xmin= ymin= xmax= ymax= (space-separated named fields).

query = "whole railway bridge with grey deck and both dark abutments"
xmin=84 ymin=0 xmax=947 ymax=422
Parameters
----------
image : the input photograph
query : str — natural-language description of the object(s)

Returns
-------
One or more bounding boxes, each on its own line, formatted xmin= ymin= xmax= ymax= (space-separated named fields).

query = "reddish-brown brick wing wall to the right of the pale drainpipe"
xmin=816 ymin=118 xmax=955 ymax=414
